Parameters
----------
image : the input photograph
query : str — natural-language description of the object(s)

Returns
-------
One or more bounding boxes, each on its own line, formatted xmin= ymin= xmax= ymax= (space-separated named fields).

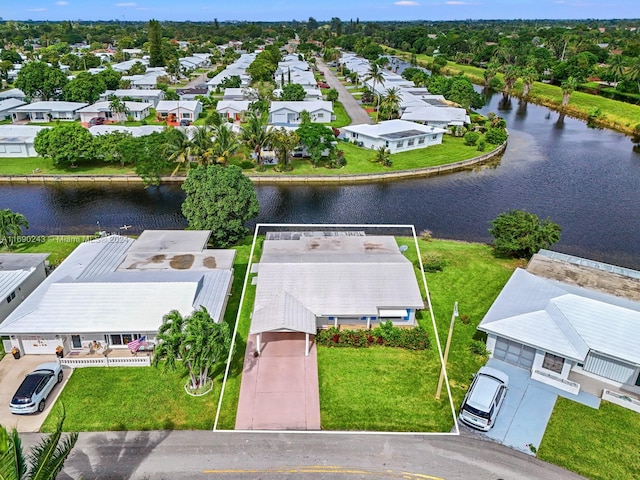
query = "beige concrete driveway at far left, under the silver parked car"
xmin=0 ymin=354 xmax=73 ymax=432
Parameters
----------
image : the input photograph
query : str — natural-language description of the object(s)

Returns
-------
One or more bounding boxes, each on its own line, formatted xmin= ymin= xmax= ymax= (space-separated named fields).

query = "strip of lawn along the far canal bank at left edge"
xmin=0 ymin=157 xmax=136 ymax=175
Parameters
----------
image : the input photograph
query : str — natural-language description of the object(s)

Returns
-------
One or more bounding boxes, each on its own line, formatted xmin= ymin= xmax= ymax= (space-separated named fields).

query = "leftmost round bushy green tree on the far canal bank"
xmin=33 ymin=123 xmax=95 ymax=167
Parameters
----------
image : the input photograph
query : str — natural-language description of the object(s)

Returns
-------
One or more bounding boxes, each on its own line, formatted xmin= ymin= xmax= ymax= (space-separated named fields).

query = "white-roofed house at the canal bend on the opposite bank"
xmin=343 ymin=120 xmax=447 ymax=153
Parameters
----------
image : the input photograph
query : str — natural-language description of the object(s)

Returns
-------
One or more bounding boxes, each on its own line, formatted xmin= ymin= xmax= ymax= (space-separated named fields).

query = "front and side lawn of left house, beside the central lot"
xmin=42 ymin=237 xmax=253 ymax=432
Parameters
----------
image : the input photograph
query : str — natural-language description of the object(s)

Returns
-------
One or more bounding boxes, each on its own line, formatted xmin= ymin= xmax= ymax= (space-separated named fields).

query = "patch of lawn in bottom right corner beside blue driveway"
xmin=538 ymin=398 xmax=640 ymax=480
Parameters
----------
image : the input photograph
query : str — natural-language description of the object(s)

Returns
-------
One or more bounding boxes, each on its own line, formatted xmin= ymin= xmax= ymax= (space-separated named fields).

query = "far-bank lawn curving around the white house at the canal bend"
xmin=251 ymin=135 xmax=488 ymax=176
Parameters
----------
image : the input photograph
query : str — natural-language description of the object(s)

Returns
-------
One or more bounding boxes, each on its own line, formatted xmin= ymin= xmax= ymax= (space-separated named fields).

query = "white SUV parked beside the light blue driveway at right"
xmin=458 ymin=367 xmax=509 ymax=432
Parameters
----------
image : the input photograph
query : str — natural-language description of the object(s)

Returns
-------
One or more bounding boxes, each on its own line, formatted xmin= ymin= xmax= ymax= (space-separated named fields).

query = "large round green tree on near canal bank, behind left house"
xmin=182 ymin=165 xmax=260 ymax=248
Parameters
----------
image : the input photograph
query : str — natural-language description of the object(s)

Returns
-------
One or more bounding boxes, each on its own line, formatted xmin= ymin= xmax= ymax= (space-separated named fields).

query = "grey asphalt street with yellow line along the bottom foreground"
xmin=16 ymin=431 xmax=582 ymax=480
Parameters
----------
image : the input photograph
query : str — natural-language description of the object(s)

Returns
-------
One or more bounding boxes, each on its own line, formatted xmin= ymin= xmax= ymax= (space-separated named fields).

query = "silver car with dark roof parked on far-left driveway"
xmin=9 ymin=362 xmax=63 ymax=415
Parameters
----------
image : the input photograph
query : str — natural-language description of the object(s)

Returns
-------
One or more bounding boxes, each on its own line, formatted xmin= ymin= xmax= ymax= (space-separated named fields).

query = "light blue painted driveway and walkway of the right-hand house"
xmin=465 ymin=358 xmax=600 ymax=455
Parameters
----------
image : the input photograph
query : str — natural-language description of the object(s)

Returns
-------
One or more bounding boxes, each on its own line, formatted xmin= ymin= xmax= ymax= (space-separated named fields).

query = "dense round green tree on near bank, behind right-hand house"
xmin=489 ymin=210 xmax=562 ymax=258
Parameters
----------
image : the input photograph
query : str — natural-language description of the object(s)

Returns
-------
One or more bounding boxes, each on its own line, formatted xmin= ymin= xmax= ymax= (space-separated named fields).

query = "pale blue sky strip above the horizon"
xmin=0 ymin=0 xmax=640 ymax=21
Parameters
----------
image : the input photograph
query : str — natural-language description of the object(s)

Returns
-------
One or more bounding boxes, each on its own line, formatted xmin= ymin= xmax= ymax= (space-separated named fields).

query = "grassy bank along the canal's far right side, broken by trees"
xmin=383 ymin=47 xmax=640 ymax=133
